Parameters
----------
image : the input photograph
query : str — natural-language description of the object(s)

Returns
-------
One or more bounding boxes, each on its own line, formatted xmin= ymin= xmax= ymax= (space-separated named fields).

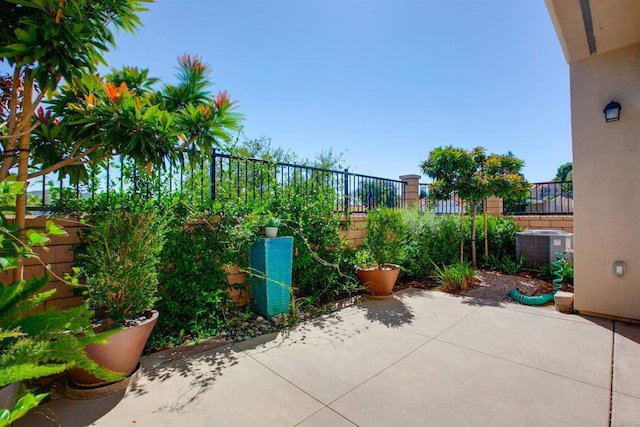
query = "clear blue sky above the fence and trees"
xmin=106 ymin=0 xmax=571 ymax=182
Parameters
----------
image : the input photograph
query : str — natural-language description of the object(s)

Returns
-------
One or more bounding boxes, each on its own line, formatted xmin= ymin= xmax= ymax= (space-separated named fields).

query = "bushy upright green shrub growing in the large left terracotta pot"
xmin=78 ymin=209 xmax=166 ymax=321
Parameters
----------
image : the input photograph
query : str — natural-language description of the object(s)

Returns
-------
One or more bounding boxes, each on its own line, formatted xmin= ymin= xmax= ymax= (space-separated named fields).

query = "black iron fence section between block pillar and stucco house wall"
xmin=503 ymin=181 xmax=573 ymax=215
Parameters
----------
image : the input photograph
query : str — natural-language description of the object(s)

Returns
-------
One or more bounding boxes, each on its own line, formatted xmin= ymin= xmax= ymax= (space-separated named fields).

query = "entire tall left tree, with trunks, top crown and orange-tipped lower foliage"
xmin=0 ymin=0 xmax=240 ymax=232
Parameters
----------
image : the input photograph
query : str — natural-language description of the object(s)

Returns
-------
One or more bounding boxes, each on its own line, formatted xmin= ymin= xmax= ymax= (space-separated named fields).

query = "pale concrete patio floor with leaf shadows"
xmin=18 ymin=289 xmax=640 ymax=427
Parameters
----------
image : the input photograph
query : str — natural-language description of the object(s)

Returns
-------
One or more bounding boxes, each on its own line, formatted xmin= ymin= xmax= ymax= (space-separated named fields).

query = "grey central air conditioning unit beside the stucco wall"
xmin=516 ymin=230 xmax=573 ymax=270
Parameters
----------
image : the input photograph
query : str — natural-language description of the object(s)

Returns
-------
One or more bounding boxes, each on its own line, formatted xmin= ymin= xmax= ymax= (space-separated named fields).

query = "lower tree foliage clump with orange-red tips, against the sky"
xmin=33 ymin=55 xmax=241 ymax=182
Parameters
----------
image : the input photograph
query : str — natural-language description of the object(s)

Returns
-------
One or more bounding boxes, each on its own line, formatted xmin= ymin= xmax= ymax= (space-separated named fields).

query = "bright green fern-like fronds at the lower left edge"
xmin=0 ymin=180 xmax=121 ymax=387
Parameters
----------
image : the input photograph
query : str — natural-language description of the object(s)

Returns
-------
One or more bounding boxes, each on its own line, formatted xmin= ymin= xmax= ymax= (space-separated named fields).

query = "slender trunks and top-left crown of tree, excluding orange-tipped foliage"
xmin=0 ymin=0 xmax=149 ymax=229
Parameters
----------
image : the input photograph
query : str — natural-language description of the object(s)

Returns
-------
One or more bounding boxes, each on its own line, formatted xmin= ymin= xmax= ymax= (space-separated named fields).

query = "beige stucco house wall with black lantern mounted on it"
xmin=570 ymin=44 xmax=640 ymax=320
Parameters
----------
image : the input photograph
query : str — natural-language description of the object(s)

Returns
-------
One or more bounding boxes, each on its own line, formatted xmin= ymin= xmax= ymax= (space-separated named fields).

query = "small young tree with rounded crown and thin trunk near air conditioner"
xmin=421 ymin=146 xmax=529 ymax=267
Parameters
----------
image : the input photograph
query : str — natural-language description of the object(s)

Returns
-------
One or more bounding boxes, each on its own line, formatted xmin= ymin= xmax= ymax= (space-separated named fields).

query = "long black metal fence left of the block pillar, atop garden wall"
xmin=27 ymin=150 xmax=406 ymax=213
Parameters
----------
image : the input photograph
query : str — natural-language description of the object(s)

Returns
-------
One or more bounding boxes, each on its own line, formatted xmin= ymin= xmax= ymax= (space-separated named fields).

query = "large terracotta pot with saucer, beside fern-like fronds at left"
xmin=69 ymin=310 xmax=158 ymax=387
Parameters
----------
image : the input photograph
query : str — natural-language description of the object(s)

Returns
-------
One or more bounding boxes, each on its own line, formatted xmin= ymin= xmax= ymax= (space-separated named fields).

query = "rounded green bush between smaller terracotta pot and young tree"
xmin=401 ymin=210 xmax=463 ymax=280
